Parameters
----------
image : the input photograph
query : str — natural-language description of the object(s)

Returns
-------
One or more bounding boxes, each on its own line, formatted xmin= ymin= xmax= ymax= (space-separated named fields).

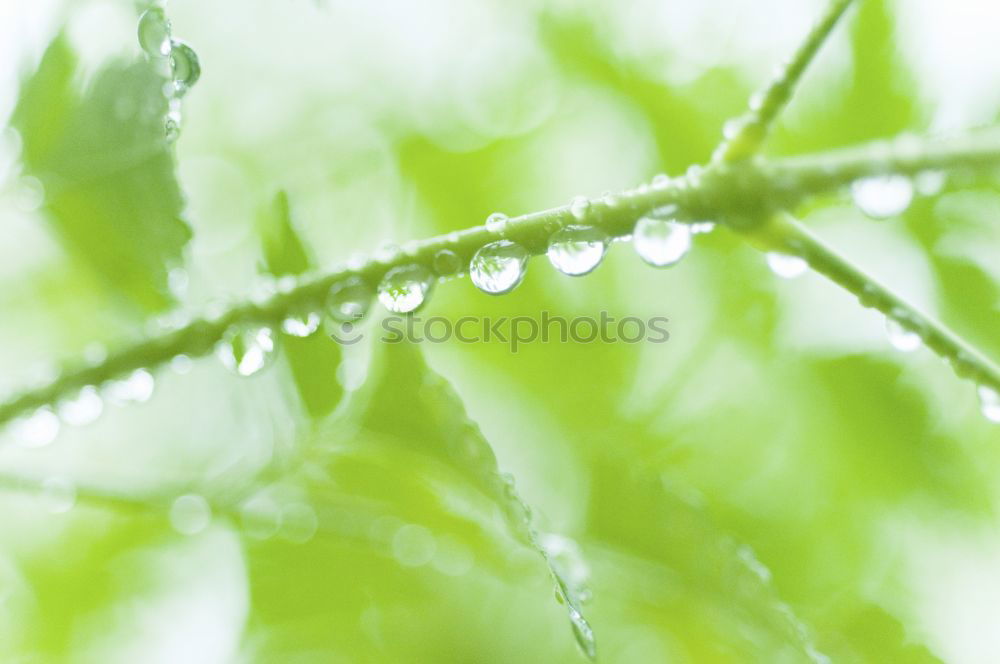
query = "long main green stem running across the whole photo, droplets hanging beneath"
xmin=0 ymin=131 xmax=1000 ymax=425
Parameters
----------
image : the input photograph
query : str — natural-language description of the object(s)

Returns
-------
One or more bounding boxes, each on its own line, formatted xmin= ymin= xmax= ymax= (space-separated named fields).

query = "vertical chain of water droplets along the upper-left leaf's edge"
xmin=138 ymin=6 xmax=201 ymax=142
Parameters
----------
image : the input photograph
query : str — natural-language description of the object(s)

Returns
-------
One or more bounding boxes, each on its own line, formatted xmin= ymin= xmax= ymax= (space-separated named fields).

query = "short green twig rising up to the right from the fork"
xmin=712 ymin=0 xmax=851 ymax=161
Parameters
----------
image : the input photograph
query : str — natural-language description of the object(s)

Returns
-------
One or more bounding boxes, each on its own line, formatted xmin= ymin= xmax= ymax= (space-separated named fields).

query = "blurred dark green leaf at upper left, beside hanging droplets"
xmin=11 ymin=36 xmax=191 ymax=312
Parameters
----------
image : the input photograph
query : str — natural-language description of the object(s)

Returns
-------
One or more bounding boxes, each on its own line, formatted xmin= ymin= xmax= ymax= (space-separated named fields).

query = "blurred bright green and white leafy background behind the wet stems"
xmin=0 ymin=0 xmax=1000 ymax=663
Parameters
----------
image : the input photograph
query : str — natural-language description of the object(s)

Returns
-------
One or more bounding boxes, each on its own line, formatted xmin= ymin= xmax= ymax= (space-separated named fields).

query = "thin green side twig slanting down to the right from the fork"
xmin=752 ymin=214 xmax=1000 ymax=391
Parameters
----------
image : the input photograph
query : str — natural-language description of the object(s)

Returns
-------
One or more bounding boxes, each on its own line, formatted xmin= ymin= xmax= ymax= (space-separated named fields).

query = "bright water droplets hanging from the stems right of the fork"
xmin=766 ymin=171 xmax=1000 ymax=423
